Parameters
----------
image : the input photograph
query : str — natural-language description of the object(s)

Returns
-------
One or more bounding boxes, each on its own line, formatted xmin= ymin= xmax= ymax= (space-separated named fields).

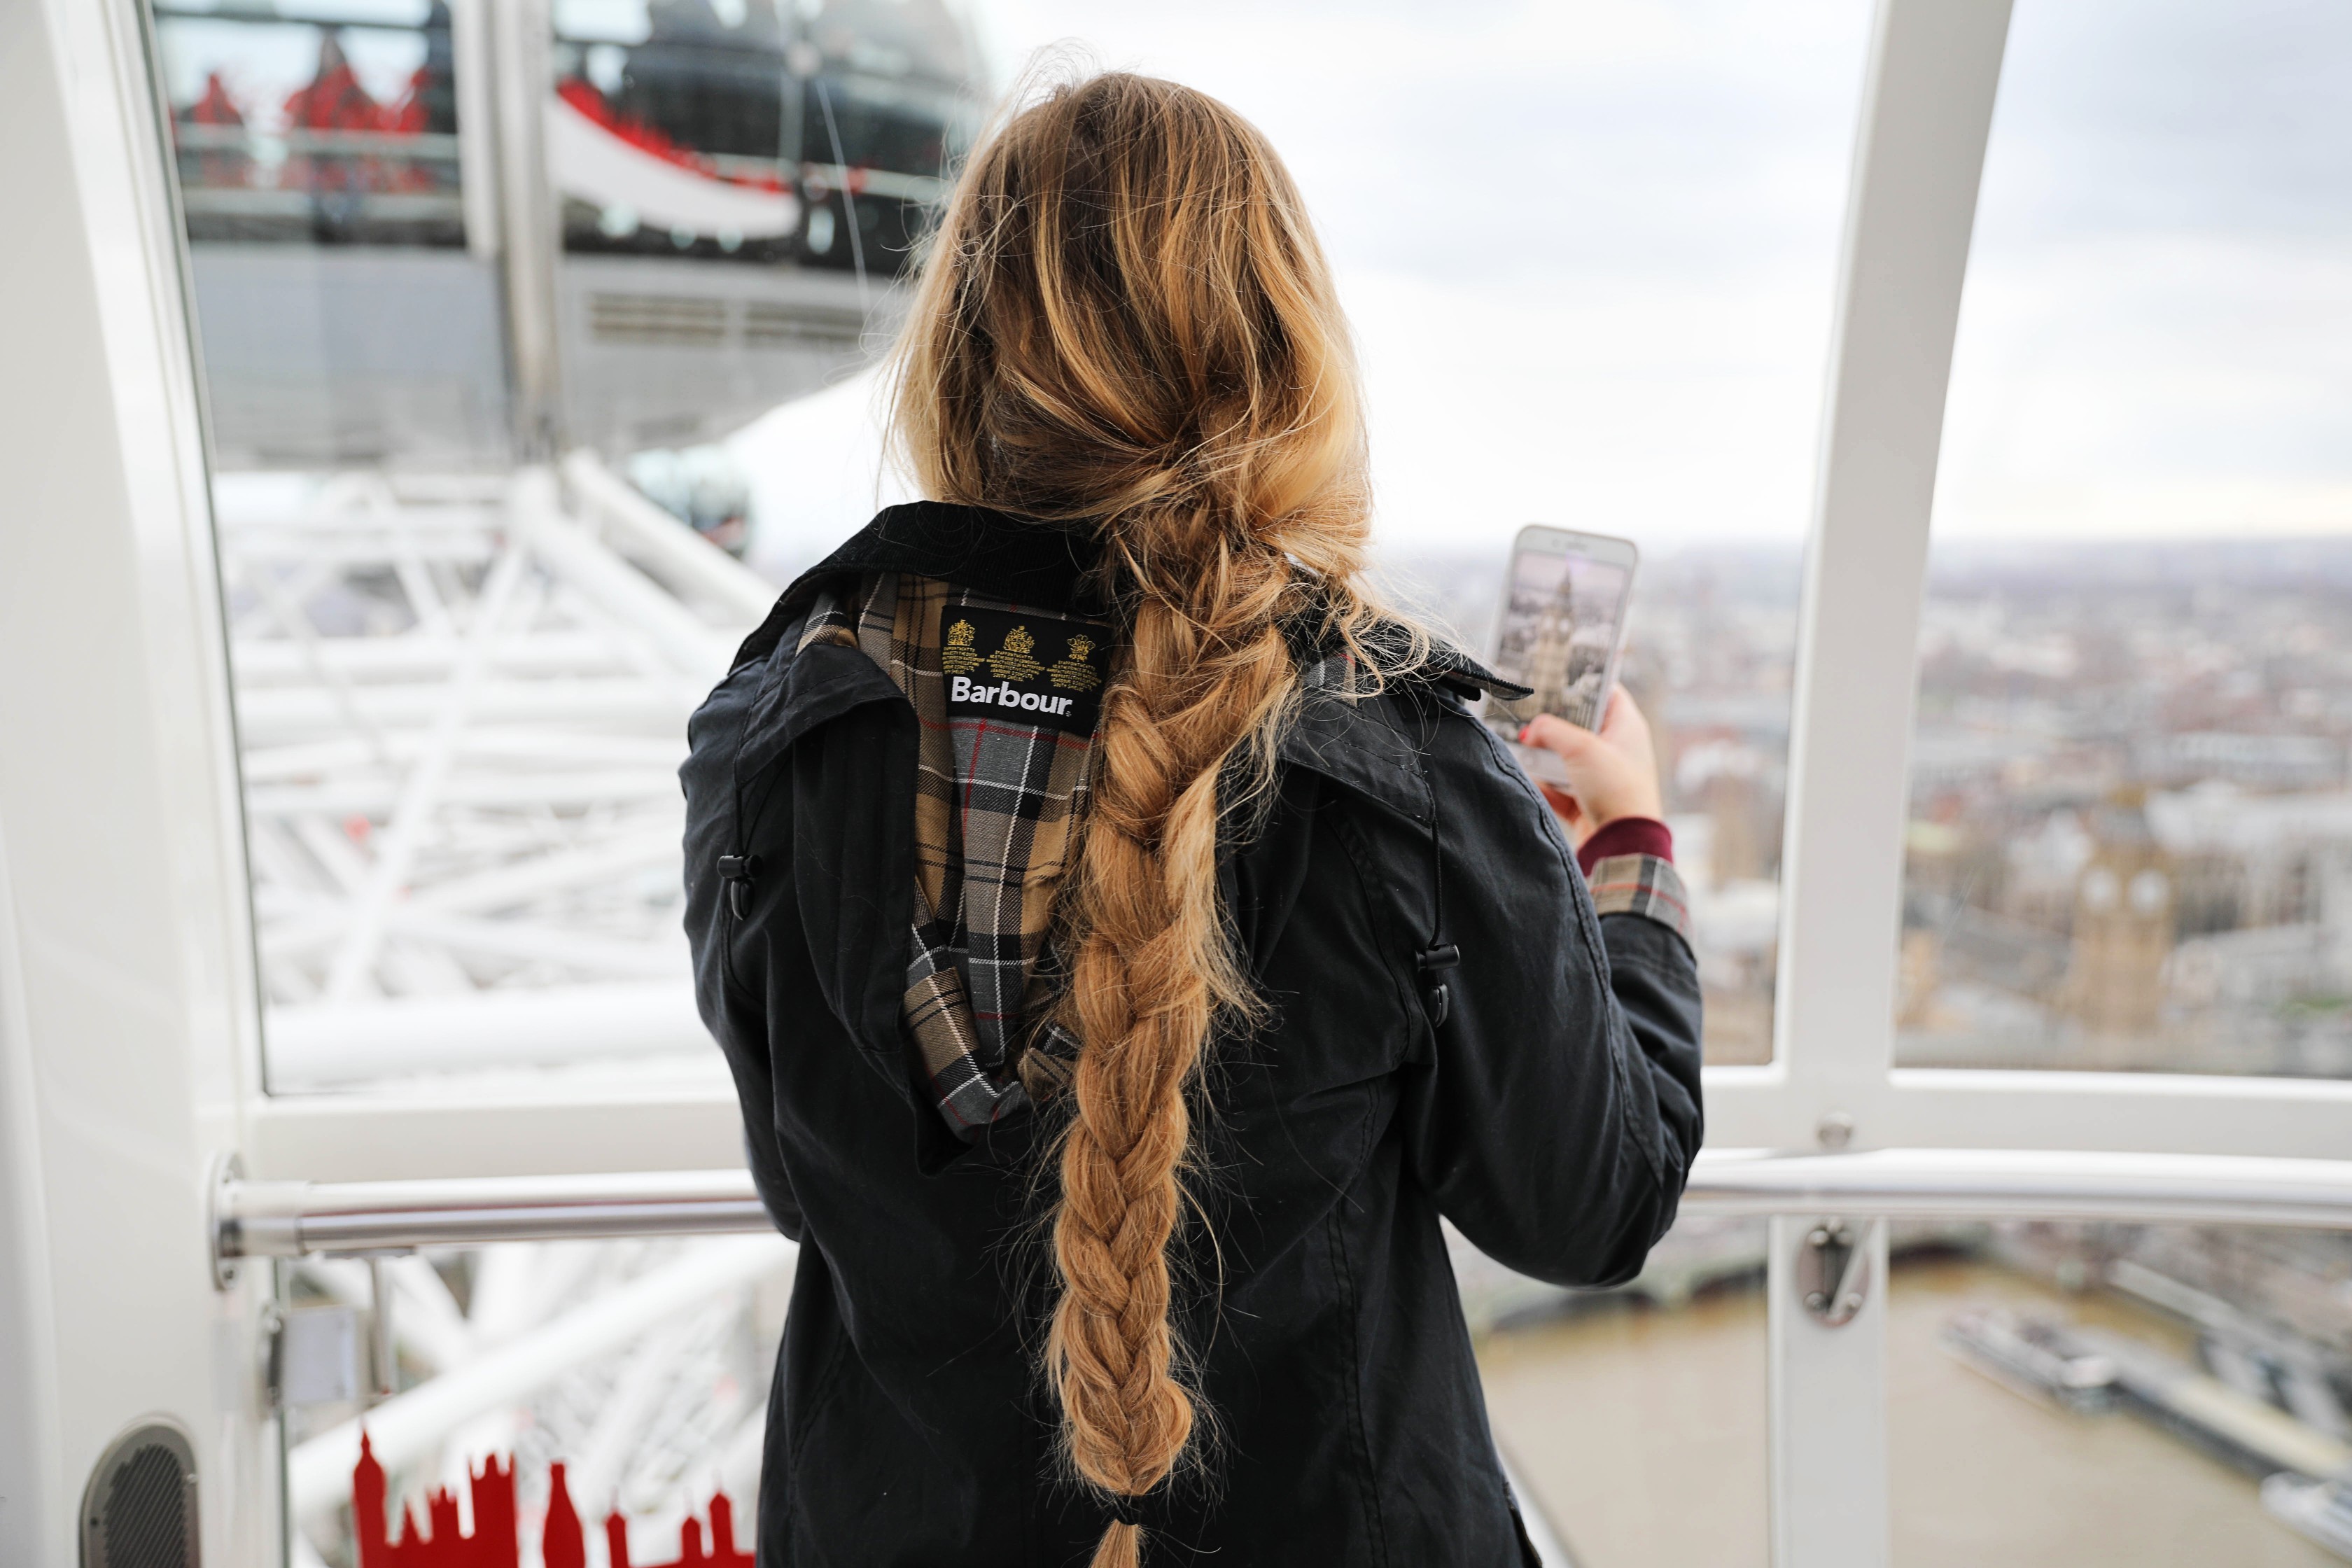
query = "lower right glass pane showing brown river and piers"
xmin=1886 ymin=1225 xmax=2352 ymax=1568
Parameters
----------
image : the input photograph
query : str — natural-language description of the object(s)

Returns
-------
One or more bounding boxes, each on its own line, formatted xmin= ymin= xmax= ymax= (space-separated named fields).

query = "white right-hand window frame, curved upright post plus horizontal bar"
xmin=1749 ymin=0 xmax=2352 ymax=1568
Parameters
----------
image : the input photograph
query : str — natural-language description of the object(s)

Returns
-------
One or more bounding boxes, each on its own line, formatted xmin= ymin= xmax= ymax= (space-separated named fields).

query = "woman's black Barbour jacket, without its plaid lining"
xmin=682 ymin=503 xmax=1700 ymax=1568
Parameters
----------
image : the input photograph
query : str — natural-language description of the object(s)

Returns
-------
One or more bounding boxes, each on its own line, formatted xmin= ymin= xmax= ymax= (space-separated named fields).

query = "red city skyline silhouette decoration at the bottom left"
xmin=351 ymin=1432 xmax=752 ymax=1568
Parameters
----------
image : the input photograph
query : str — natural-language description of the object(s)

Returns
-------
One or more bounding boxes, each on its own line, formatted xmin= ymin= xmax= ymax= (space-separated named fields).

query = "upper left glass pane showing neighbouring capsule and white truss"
xmin=153 ymin=0 xmax=979 ymax=1093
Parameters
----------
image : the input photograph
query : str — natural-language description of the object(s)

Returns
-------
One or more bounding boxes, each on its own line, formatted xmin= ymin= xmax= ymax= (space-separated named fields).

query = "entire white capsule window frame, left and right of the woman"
xmin=13 ymin=0 xmax=2352 ymax=1568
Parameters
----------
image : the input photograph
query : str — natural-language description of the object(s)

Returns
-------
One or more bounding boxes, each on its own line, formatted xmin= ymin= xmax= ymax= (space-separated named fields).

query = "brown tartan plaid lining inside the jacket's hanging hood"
xmin=799 ymin=571 xmax=1108 ymax=1140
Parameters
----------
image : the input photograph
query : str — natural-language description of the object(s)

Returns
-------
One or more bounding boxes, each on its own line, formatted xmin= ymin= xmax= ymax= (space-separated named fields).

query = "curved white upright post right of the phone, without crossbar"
xmin=1766 ymin=0 xmax=2008 ymax=1568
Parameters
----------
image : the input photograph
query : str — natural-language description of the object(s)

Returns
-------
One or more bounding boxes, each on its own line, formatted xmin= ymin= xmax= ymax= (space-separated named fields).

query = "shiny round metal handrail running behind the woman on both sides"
xmin=211 ymin=1149 xmax=2352 ymax=1262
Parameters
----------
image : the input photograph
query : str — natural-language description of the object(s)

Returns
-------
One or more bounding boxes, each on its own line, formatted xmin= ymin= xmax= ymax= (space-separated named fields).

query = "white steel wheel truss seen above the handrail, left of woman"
xmin=216 ymin=454 xmax=774 ymax=1093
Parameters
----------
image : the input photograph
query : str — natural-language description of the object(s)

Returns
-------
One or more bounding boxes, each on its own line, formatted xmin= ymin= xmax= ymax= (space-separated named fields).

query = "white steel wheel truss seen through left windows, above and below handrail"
xmin=216 ymin=454 xmax=792 ymax=1556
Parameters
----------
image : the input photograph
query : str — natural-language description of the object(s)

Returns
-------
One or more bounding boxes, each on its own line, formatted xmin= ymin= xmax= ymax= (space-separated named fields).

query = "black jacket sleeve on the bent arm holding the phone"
xmin=1402 ymin=710 xmax=1703 ymax=1286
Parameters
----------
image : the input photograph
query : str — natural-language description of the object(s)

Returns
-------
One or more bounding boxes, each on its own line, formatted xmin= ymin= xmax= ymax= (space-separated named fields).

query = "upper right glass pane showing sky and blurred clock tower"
xmin=1898 ymin=0 xmax=2352 ymax=1077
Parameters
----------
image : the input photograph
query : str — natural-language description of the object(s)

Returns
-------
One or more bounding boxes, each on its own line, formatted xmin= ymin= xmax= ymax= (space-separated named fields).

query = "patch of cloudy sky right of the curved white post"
xmin=1935 ymin=0 xmax=2352 ymax=538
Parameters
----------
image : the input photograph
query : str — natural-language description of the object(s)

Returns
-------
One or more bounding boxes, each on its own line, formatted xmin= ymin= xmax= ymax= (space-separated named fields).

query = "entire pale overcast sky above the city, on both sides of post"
xmin=738 ymin=0 xmax=2352 ymax=571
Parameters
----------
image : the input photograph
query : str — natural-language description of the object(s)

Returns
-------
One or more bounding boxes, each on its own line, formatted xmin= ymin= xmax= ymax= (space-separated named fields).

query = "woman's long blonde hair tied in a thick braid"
xmin=894 ymin=73 xmax=1373 ymax=1568
